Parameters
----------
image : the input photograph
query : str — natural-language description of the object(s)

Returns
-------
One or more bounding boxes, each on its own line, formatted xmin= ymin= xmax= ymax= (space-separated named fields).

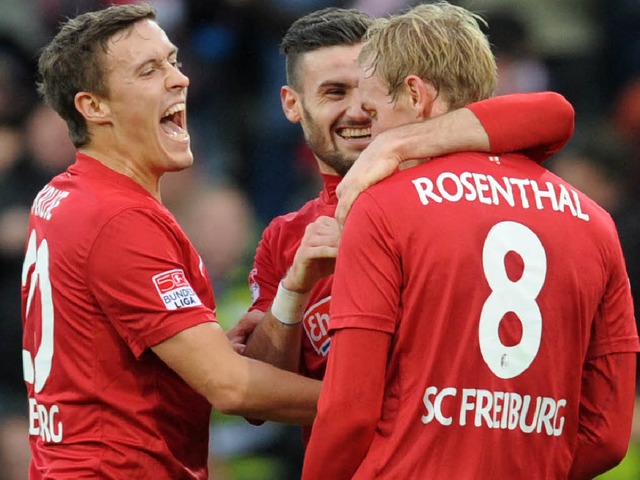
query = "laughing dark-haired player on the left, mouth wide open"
xmin=22 ymin=4 xmax=320 ymax=480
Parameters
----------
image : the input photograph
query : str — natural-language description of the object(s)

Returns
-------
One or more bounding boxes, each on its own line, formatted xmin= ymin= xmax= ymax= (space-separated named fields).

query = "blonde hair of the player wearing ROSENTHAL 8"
xmin=360 ymin=2 xmax=498 ymax=109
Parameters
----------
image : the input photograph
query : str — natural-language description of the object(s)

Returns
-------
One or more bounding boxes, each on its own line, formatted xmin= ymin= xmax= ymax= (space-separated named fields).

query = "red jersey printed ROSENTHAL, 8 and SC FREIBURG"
xmin=303 ymin=153 xmax=640 ymax=480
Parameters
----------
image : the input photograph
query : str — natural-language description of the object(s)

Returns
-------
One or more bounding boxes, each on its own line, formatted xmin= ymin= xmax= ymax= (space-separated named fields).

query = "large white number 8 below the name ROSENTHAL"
xmin=478 ymin=222 xmax=547 ymax=378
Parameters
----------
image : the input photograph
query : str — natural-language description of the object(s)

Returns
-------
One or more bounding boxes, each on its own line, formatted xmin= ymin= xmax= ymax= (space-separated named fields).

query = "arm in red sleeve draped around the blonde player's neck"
xmin=336 ymin=92 xmax=575 ymax=224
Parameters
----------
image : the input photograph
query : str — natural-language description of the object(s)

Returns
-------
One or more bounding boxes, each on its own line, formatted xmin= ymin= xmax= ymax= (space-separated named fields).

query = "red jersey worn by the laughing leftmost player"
xmin=22 ymin=154 xmax=215 ymax=479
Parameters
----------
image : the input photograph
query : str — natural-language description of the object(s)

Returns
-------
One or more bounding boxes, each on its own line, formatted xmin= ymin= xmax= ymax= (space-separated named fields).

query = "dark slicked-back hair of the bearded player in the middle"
xmin=280 ymin=7 xmax=373 ymax=88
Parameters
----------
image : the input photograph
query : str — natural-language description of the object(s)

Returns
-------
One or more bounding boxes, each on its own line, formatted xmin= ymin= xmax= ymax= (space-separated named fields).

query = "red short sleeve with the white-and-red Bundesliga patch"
xmin=87 ymin=209 xmax=215 ymax=356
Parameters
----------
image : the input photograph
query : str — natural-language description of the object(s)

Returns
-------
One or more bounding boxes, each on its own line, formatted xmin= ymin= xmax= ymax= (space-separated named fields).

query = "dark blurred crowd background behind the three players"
xmin=0 ymin=0 xmax=640 ymax=480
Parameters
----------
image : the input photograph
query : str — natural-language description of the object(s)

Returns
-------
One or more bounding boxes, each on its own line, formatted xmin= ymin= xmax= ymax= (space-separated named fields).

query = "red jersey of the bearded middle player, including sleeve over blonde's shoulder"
xmin=249 ymin=92 xmax=573 ymax=439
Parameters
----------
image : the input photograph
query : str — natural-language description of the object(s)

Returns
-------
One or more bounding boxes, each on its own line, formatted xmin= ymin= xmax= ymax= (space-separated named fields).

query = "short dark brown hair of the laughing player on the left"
xmin=38 ymin=4 xmax=156 ymax=148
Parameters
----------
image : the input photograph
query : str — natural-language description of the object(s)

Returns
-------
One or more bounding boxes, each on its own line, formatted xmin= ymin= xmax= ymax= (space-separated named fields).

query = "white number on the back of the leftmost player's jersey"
xmin=22 ymin=230 xmax=54 ymax=393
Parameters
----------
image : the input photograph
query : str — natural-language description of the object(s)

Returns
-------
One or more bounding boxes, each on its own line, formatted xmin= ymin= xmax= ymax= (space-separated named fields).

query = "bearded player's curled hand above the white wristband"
xmin=282 ymin=216 xmax=340 ymax=293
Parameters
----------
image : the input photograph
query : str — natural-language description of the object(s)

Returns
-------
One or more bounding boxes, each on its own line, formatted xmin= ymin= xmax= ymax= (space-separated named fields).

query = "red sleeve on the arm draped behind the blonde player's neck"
xmin=467 ymin=92 xmax=575 ymax=163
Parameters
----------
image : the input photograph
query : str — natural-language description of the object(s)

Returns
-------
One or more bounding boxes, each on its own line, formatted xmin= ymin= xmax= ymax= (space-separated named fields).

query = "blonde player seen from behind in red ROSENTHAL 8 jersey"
xmin=302 ymin=2 xmax=640 ymax=480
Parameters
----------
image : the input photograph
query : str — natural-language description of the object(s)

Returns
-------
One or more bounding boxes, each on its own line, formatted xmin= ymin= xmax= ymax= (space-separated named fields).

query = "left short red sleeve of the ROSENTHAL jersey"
xmin=330 ymin=192 xmax=402 ymax=333
